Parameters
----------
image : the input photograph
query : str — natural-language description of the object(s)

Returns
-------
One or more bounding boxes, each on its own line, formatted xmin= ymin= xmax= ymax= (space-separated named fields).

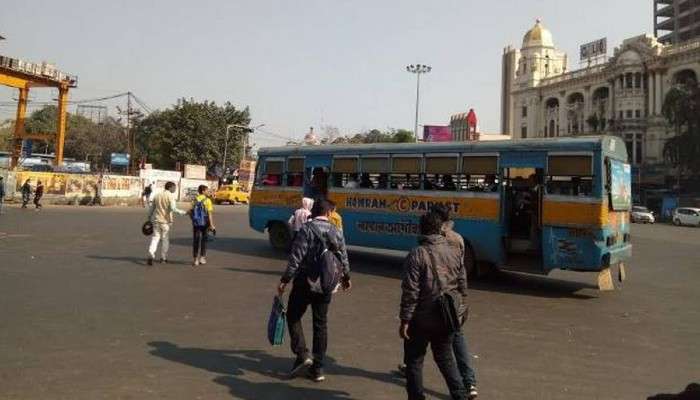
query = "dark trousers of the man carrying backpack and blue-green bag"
xmin=287 ymin=279 xmax=331 ymax=368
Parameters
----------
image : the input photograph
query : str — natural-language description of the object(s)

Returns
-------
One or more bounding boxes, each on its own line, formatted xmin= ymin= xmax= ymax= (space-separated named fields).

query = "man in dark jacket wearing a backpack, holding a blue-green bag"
xmin=277 ymin=199 xmax=352 ymax=382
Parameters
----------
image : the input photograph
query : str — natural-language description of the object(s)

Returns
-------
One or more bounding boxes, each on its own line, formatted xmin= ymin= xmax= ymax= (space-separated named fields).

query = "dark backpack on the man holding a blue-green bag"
xmin=306 ymin=222 xmax=343 ymax=295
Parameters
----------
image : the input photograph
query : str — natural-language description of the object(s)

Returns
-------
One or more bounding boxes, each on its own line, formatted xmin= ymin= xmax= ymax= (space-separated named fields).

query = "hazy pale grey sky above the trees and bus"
xmin=0 ymin=0 xmax=653 ymax=145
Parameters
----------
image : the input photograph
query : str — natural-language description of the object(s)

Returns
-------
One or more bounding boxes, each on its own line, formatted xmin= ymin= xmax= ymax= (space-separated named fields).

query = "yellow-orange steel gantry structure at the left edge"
xmin=0 ymin=56 xmax=78 ymax=169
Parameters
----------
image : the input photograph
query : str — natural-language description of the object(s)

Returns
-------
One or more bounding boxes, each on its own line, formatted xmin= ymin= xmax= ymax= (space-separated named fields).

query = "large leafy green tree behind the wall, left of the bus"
xmin=134 ymin=99 xmax=250 ymax=170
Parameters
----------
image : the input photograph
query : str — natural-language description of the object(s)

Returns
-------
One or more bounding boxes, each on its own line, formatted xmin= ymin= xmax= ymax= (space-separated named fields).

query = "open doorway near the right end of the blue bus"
xmin=500 ymin=152 xmax=547 ymax=267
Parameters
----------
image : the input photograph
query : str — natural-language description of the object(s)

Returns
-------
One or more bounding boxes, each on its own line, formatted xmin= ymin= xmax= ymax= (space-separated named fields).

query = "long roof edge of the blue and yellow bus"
xmin=258 ymin=135 xmax=627 ymax=160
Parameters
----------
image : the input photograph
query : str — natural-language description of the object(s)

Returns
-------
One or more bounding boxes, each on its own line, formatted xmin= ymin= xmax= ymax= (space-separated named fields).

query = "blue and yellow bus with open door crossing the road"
xmin=249 ymin=136 xmax=631 ymax=288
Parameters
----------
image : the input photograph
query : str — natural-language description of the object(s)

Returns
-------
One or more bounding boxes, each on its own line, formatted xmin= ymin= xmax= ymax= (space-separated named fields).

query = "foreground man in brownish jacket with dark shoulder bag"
xmin=399 ymin=212 xmax=467 ymax=400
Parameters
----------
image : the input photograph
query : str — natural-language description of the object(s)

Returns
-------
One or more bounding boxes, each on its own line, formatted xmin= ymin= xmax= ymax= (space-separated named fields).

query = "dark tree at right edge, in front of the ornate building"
xmin=661 ymin=82 xmax=700 ymax=177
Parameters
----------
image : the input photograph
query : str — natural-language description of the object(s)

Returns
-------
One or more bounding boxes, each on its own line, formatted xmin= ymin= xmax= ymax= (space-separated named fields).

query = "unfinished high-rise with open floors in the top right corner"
xmin=654 ymin=0 xmax=700 ymax=44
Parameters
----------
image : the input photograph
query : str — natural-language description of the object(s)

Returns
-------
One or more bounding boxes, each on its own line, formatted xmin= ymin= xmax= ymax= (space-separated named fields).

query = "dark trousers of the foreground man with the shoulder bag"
xmin=404 ymin=322 xmax=467 ymax=400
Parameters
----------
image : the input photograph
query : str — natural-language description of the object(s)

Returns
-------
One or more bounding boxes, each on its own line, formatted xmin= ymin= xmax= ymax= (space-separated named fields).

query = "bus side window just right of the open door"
xmin=547 ymin=155 xmax=593 ymax=196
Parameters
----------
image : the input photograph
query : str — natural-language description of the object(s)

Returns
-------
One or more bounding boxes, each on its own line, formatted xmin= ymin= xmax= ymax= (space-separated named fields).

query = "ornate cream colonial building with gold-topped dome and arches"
xmin=501 ymin=21 xmax=700 ymax=185
